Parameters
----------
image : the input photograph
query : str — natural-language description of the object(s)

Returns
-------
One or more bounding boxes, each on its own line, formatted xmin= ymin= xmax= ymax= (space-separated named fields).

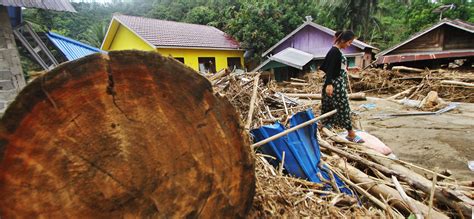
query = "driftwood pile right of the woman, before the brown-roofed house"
xmin=351 ymin=66 xmax=474 ymax=103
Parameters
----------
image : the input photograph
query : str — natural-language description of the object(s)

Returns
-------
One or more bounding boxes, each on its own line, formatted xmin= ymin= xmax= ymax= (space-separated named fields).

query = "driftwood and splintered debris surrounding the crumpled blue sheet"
xmin=209 ymin=72 xmax=474 ymax=218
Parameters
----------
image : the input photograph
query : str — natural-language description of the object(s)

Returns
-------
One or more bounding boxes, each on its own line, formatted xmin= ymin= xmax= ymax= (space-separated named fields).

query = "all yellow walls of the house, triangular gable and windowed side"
xmin=101 ymin=20 xmax=244 ymax=71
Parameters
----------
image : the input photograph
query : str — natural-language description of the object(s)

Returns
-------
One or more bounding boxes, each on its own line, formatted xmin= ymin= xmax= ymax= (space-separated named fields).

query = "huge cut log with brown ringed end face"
xmin=0 ymin=51 xmax=255 ymax=218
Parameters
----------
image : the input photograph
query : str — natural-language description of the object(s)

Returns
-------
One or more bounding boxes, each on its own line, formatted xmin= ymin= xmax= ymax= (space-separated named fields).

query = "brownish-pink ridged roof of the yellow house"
xmin=114 ymin=14 xmax=240 ymax=49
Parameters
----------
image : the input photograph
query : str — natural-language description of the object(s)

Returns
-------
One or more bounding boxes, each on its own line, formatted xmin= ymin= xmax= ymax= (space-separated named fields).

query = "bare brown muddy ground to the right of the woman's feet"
xmin=351 ymin=98 xmax=474 ymax=180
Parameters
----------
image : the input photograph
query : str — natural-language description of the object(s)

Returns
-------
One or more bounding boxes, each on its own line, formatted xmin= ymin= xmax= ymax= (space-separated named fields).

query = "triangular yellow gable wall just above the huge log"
xmin=107 ymin=25 xmax=154 ymax=51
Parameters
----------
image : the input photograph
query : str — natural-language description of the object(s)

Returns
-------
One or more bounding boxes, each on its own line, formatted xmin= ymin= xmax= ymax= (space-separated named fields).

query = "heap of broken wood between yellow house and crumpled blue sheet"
xmin=208 ymin=71 xmax=319 ymax=130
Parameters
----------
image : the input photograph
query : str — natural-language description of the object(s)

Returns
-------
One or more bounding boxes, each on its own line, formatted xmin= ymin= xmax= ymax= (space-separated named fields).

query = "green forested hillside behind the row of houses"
xmin=24 ymin=0 xmax=474 ymax=57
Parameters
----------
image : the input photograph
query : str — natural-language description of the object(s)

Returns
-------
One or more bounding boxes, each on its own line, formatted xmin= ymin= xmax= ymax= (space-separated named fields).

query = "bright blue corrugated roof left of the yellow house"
xmin=46 ymin=32 xmax=103 ymax=61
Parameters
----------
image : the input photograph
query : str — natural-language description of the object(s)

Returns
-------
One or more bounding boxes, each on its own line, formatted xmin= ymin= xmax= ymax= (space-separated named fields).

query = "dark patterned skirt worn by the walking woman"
xmin=321 ymin=71 xmax=352 ymax=130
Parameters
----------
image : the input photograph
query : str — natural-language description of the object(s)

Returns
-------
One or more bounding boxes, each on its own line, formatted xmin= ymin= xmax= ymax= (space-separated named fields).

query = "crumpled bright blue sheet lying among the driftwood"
xmin=251 ymin=109 xmax=352 ymax=195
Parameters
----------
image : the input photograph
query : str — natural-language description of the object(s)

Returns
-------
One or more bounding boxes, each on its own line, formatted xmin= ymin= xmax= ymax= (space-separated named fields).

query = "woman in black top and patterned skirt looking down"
xmin=321 ymin=30 xmax=364 ymax=143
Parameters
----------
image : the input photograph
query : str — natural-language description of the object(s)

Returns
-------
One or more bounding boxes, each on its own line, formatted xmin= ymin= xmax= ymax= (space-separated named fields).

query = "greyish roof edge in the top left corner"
xmin=0 ymin=0 xmax=76 ymax=12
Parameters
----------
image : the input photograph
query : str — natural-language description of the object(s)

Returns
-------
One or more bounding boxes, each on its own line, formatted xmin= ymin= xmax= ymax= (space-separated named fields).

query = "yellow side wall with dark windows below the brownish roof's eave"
xmin=157 ymin=48 xmax=244 ymax=71
